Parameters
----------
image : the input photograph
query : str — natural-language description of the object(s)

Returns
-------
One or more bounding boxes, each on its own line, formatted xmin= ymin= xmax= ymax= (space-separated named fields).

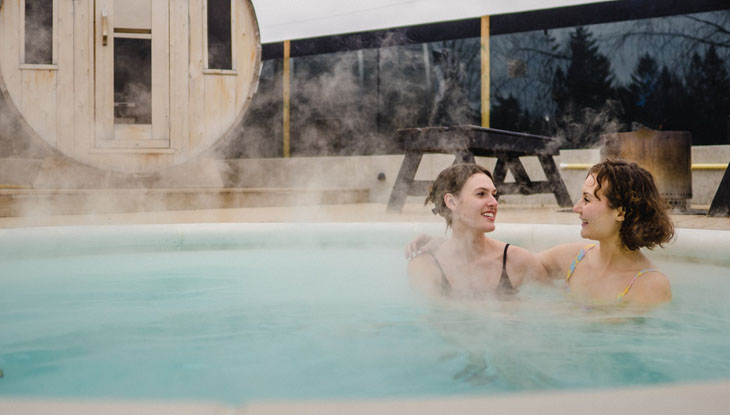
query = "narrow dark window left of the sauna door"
xmin=25 ymin=0 xmax=53 ymax=64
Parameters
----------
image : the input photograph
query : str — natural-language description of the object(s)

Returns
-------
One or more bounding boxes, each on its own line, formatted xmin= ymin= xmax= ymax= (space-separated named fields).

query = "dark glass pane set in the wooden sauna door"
xmin=114 ymin=38 xmax=152 ymax=124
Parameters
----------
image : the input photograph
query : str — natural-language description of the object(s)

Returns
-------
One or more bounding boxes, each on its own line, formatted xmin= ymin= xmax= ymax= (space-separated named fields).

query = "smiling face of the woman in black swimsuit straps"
xmin=445 ymin=173 xmax=498 ymax=232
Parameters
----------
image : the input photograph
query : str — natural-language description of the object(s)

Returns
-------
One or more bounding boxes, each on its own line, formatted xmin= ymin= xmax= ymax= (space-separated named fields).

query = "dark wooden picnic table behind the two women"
xmin=387 ymin=125 xmax=573 ymax=212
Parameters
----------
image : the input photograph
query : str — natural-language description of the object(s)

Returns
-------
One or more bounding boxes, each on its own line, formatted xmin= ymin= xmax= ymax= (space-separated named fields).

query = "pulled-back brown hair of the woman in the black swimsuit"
xmin=423 ymin=163 xmax=494 ymax=229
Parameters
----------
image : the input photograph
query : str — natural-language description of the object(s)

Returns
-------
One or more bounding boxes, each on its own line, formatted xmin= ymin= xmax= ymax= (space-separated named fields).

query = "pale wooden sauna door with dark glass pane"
xmin=94 ymin=0 xmax=170 ymax=149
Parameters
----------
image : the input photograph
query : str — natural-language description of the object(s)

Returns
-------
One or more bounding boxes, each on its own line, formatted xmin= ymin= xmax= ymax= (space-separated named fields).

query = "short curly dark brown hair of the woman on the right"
xmin=588 ymin=159 xmax=674 ymax=251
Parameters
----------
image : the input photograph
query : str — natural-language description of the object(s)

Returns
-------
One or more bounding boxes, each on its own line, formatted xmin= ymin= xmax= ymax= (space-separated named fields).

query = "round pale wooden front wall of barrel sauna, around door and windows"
xmin=0 ymin=0 xmax=261 ymax=170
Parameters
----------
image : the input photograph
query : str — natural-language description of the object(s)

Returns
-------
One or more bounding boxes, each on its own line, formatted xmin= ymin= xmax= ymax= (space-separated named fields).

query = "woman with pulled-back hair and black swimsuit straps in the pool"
xmin=408 ymin=164 xmax=546 ymax=298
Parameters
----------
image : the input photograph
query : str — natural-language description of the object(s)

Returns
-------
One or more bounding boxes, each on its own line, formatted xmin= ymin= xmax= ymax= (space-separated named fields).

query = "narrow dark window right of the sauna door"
xmin=208 ymin=0 xmax=233 ymax=69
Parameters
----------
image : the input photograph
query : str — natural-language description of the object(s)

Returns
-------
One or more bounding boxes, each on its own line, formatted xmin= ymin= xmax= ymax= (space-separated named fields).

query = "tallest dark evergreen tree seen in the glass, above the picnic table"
xmin=553 ymin=27 xmax=615 ymax=147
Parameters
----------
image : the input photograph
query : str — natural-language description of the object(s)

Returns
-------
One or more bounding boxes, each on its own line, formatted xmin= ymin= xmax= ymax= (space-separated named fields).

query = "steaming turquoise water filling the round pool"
xmin=0 ymin=226 xmax=730 ymax=404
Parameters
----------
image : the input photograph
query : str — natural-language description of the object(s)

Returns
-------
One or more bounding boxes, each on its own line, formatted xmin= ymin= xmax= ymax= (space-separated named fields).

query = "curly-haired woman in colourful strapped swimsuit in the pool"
xmin=538 ymin=160 xmax=674 ymax=307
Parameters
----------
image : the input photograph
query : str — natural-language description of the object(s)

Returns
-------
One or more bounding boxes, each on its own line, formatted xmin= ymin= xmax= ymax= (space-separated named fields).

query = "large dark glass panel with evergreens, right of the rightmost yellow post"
xmin=491 ymin=10 xmax=730 ymax=148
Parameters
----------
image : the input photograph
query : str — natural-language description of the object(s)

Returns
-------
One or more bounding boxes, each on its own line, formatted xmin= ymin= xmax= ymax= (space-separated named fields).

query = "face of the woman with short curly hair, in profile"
xmin=573 ymin=174 xmax=623 ymax=241
